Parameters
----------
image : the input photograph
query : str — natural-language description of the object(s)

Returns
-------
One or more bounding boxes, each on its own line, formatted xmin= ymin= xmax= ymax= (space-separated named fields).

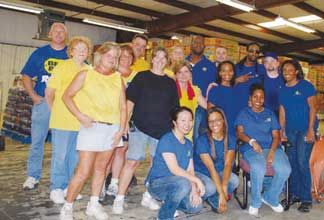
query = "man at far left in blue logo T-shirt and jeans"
xmin=21 ymin=23 xmax=68 ymax=190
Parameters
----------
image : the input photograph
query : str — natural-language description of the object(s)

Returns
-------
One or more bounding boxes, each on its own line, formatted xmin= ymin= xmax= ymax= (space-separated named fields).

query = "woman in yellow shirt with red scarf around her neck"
xmin=174 ymin=61 xmax=207 ymax=141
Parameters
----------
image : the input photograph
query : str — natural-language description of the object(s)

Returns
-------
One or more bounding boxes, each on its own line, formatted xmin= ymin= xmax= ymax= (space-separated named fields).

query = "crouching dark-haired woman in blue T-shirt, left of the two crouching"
xmin=147 ymin=107 xmax=216 ymax=220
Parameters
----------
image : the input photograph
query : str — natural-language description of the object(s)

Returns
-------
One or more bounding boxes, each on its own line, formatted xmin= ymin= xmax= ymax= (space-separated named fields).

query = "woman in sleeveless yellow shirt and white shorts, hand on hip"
xmin=60 ymin=42 xmax=126 ymax=220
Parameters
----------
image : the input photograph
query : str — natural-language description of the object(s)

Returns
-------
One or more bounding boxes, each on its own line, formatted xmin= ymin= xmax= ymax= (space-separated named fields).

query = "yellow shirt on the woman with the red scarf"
xmin=179 ymin=85 xmax=201 ymax=141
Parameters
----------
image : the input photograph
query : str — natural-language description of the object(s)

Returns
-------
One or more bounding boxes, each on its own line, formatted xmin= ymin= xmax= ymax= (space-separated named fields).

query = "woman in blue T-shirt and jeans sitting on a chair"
xmin=235 ymin=84 xmax=291 ymax=216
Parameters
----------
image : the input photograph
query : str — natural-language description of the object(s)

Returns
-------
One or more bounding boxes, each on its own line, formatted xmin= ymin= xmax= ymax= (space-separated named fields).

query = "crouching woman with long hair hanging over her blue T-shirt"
xmin=194 ymin=107 xmax=239 ymax=213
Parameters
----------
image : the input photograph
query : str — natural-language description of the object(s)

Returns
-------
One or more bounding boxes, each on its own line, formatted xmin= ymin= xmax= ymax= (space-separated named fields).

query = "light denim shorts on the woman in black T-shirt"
xmin=126 ymin=127 xmax=159 ymax=160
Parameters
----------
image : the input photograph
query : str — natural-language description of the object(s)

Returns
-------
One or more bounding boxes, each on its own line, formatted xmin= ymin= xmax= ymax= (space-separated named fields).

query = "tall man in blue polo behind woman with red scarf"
xmin=186 ymin=36 xmax=217 ymax=141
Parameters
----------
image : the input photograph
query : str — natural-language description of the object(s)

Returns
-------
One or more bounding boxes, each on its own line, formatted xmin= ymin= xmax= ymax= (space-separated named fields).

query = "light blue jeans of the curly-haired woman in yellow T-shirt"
xmin=50 ymin=129 xmax=79 ymax=190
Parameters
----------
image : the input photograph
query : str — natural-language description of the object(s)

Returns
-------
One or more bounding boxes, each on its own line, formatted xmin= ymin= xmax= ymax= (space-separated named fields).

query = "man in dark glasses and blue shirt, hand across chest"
xmin=235 ymin=43 xmax=265 ymax=112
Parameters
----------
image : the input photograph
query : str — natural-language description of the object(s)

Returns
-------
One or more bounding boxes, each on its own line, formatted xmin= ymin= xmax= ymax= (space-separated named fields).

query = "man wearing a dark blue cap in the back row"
xmin=263 ymin=52 xmax=284 ymax=116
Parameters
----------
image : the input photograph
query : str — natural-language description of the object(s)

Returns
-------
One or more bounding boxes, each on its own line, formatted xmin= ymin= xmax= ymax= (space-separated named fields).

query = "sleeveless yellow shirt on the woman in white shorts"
xmin=75 ymin=70 xmax=122 ymax=124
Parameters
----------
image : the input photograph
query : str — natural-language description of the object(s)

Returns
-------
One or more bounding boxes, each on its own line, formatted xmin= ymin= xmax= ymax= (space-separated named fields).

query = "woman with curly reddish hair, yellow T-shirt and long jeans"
xmin=45 ymin=36 xmax=92 ymax=204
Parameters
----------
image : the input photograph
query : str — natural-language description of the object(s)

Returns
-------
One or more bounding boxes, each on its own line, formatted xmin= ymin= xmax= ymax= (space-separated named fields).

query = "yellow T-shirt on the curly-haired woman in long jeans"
xmin=47 ymin=59 xmax=91 ymax=131
